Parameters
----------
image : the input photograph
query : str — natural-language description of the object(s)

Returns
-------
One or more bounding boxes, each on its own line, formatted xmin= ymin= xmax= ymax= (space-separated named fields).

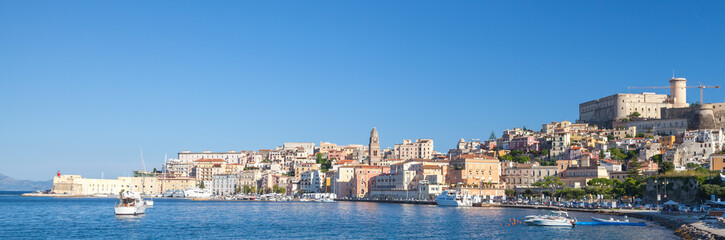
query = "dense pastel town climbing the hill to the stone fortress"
xmin=51 ymin=78 xmax=725 ymax=205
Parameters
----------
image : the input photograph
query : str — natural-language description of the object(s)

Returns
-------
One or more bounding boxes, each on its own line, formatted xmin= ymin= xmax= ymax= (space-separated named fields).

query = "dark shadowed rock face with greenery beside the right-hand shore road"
xmin=642 ymin=177 xmax=701 ymax=205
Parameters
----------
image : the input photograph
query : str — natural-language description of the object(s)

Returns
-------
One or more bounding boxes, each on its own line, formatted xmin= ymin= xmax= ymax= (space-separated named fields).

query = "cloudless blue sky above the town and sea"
xmin=0 ymin=0 xmax=725 ymax=180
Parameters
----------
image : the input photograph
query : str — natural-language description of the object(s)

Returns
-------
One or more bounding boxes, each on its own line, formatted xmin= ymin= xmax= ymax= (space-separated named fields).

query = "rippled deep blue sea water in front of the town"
xmin=0 ymin=193 xmax=678 ymax=240
